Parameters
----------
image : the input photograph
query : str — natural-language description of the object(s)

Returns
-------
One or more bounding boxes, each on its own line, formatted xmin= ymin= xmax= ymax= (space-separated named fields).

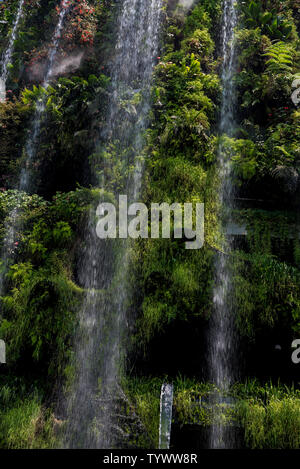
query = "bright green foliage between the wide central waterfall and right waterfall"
xmin=135 ymin=2 xmax=221 ymax=347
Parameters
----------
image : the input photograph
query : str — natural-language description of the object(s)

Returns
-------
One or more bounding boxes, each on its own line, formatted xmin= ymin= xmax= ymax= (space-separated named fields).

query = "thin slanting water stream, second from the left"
xmin=0 ymin=0 xmax=69 ymax=314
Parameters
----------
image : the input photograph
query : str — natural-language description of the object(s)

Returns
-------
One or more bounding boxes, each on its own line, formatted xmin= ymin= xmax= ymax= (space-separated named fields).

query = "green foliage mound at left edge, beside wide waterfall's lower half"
xmin=0 ymin=189 xmax=98 ymax=376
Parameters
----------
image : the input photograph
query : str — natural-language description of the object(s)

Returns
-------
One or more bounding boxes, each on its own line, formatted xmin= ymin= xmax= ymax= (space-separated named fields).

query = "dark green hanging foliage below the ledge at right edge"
xmin=233 ymin=254 xmax=300 ymax=339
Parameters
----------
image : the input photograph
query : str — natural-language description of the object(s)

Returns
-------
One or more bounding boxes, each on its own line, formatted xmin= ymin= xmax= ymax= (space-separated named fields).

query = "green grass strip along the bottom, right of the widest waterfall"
xmin=125 ymin=377 xmax=300 ymax=449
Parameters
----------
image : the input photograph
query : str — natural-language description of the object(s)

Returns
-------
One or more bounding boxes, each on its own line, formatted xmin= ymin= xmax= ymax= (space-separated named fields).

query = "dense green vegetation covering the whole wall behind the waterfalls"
xmin=0 ymin=0 xmax=300 ymax=448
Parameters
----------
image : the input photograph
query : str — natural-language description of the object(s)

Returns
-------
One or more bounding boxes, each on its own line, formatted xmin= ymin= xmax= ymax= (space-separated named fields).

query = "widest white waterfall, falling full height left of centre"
xmin=63 ymin=0 xmax=162 ymax=448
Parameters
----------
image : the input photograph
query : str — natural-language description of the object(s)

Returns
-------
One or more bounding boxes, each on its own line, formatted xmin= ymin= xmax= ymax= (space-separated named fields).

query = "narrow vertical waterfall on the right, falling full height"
xmin=208 ymin=0 xmax=237 ymax=448
